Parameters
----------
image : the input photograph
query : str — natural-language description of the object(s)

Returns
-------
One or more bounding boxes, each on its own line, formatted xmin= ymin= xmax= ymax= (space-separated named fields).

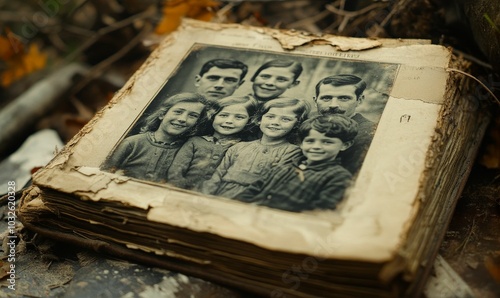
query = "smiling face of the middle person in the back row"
xmin=252 ymin=67 xmax=298 ymax=100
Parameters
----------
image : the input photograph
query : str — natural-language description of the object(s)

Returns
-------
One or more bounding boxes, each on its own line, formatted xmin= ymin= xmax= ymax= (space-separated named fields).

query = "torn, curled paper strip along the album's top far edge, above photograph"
xmin=267 ymin=30 xmax=382 ymax=52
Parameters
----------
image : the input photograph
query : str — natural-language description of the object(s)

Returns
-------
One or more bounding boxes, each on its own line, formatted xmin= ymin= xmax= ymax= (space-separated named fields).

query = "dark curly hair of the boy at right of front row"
xmin=298 ymin=115 xmax=358 ymax=143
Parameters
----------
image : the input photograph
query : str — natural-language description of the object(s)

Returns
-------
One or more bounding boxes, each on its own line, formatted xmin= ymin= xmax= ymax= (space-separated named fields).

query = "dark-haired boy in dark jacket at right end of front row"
xmin=235 ymin=115 xmax=358 ymax=212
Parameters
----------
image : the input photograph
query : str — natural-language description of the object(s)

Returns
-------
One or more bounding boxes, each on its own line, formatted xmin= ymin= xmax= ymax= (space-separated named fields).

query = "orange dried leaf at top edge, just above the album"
xmin=155 ymin=0 xmax=219 ymax=34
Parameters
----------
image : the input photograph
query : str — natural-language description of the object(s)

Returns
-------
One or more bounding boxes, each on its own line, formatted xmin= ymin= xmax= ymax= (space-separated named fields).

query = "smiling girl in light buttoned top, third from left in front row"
xmin=202 ymin=98 xmax=309 ymax=198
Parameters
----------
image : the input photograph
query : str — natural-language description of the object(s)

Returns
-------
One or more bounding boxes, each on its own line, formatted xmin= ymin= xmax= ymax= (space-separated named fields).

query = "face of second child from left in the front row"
xmin=212 ymin=105 xmax=250 ymax=137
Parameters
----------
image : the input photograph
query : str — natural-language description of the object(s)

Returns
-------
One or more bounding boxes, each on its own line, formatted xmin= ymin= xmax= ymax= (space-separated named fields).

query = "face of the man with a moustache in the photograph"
xmin=316 ymin=84 xmax=361 ymax=117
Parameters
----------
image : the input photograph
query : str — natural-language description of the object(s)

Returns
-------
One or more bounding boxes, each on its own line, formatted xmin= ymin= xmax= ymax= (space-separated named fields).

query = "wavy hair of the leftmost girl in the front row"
xmin=141 ymin=92 xmax=207 ymax=136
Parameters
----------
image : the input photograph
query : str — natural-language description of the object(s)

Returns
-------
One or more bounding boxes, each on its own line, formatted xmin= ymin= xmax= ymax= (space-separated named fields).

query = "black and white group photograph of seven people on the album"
xmin=101 ymin=44 xmax=399 ymax=212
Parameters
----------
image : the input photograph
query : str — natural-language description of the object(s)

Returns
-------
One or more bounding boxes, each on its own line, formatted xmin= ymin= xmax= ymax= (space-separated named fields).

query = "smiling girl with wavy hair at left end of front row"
xmin=103 ymin=93 xmax=205 ymax=182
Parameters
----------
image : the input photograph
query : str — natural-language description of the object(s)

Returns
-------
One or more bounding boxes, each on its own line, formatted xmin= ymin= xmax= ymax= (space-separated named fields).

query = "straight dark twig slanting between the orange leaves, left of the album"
xmin=71 ymin=23 xmax=153 ymax=95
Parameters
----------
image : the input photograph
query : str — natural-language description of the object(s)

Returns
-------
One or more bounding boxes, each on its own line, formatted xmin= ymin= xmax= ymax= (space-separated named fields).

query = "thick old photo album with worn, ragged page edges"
xmin=20 ymin=20 xmax=488 ymax=297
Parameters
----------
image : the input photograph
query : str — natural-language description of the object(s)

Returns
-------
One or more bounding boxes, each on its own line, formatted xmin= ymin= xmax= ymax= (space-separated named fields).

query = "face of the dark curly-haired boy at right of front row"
xmin=300 ymin=129 xmax=348 ymax=164
